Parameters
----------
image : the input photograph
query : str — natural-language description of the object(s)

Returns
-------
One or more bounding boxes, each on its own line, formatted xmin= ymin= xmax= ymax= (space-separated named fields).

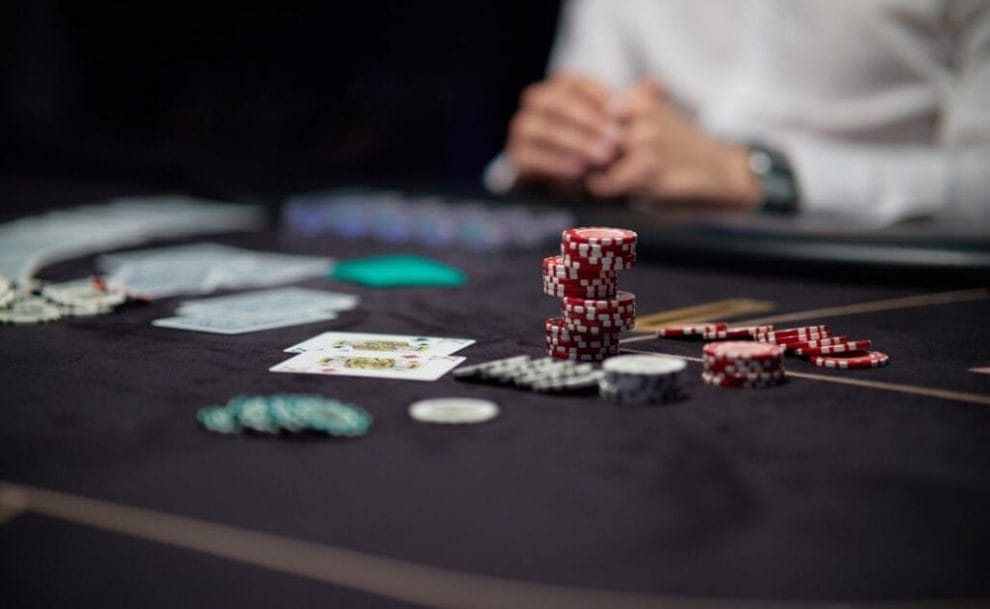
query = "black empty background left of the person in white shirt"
xmin=0 ymin=0 xmax=558 ymax=197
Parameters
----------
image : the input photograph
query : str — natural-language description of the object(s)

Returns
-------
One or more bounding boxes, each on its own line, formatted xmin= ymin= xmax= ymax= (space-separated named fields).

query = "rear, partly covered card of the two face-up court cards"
xmin=285 ymin=332 xmax=475 ymax=357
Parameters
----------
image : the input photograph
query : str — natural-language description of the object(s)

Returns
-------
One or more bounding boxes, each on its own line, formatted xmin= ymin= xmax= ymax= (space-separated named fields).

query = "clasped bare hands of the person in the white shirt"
xmin=506 ymin=74 xmax=760 ymax=208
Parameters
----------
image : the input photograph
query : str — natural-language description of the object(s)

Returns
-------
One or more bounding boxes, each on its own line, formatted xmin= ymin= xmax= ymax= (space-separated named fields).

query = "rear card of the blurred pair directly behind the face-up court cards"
xmin=176 ymin=287 xmax=360 ymax=318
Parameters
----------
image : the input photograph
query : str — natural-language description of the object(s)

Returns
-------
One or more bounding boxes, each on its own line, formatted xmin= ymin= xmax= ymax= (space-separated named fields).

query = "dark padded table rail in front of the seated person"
xmin=540 ymin=200 xmax=990 ymax=285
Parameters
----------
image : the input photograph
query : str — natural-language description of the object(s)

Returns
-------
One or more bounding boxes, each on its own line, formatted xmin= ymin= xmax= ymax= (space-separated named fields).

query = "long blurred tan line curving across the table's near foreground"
xmin=0 ymin=480 xmax=990 ymax=609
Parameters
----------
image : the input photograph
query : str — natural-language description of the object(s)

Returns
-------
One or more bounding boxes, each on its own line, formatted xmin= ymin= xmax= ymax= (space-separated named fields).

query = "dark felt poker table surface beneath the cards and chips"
xmin=0 ymin=185 xmax=990 ymax=609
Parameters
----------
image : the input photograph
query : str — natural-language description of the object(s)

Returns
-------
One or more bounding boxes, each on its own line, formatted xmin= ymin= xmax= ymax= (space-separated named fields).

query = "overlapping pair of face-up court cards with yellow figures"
xmin=270 ymin=332 xmax=475 ymax=381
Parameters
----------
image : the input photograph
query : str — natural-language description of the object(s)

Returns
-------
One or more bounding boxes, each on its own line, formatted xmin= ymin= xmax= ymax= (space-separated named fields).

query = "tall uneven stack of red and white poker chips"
xmin=543 ymin=227 xmax=637 ymax=361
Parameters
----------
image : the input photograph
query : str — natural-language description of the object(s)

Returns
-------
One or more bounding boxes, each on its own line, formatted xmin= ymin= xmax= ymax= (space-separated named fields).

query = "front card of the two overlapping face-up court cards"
xmin=269 ymin=351 xmax=466 ymax=381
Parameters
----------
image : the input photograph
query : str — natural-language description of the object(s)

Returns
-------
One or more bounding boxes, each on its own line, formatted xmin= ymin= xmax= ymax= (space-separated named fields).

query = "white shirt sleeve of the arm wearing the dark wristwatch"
xmin=782 ymin=2 xmax=990 ymax=221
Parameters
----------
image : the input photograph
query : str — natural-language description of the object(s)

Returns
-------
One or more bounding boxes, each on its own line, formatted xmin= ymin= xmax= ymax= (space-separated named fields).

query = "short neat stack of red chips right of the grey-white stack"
xmin=701 ymin=341 xmax=784 ymax=388
